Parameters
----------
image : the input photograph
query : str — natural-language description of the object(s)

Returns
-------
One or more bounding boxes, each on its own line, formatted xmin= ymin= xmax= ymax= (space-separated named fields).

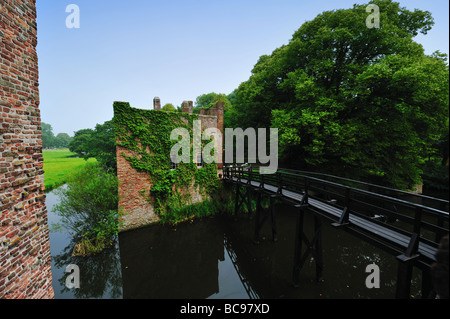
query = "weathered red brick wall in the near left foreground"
xmin=0 ymin=0 xmax=54 ymax=299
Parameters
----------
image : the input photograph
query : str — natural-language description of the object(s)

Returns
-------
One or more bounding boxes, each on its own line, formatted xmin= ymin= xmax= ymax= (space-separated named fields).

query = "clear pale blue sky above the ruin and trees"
xmin=37 ymin=0 xmax=449 ymax=136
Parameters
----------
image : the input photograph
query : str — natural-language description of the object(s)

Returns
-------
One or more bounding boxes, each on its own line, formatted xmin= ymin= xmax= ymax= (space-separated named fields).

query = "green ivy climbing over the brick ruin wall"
xmin=114 ymin=102 xmax=219 ymax=222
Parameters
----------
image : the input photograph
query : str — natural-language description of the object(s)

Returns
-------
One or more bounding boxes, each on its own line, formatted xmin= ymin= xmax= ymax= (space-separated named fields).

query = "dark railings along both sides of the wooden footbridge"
xmin=224 ymin=166 xmax=449 ymax=255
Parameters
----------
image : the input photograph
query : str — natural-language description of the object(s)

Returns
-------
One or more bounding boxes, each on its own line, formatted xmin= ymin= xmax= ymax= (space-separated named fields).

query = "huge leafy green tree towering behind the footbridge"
xmin=230 ymin=0 xmax=449 ymax=188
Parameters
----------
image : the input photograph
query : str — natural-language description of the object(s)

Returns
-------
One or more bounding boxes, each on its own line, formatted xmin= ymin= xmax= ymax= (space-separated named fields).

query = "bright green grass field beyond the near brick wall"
xmin=42 ymin=149 xmax=96 ymax=191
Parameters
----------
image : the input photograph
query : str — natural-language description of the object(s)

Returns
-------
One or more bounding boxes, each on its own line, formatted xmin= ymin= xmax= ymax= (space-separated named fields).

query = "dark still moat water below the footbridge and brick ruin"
xmin=47 ymin=192 xmax=421 ymax=299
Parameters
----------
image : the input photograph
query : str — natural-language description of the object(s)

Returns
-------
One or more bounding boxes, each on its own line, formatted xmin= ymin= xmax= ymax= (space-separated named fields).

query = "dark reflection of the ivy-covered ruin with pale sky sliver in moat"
xmin=119 ymin=219 xmax=248 ymax=299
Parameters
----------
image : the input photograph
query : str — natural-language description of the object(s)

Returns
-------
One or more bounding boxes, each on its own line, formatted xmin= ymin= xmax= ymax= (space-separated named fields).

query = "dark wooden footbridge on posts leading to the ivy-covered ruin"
xmin=223 ymin=166 xmax=449 ymax=299
